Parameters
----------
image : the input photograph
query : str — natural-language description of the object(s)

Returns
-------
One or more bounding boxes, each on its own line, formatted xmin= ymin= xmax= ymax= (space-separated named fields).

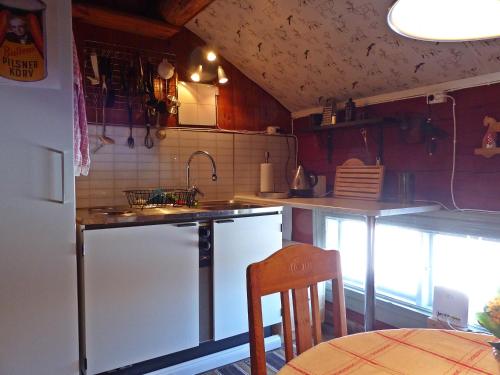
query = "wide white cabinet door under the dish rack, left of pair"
xmin=83 ymin=223 xmax=199 ymax=374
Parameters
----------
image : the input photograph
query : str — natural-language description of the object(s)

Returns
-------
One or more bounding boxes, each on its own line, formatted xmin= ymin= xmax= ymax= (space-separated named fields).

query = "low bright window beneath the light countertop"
xmin=318 ymin=215 xmax=500 ymax=323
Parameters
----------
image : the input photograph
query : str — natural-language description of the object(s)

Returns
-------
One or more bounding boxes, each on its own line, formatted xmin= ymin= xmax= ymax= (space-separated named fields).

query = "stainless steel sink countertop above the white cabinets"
xmin=76 ymin=203 xmax=282 ymax=229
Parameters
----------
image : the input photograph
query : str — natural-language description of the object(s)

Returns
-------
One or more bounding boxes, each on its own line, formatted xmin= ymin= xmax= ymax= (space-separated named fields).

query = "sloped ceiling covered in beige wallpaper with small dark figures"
xmin=186 ymin=0 xmax=500 ymax=111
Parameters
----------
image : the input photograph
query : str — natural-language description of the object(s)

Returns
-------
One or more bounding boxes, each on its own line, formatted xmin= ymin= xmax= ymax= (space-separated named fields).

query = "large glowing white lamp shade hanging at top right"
xmin=387 ymin=0 xmax=500 ymax=42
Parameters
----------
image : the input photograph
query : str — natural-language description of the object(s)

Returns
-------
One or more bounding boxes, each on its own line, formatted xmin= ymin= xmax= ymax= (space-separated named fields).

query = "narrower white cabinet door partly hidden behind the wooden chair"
xmin=213 ymin=214 xmax=282 ymax=340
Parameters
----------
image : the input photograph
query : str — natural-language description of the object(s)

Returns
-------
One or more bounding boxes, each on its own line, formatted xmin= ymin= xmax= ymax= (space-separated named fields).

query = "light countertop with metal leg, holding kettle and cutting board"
xmin=234 ymin=194 xmax=441 ymax=217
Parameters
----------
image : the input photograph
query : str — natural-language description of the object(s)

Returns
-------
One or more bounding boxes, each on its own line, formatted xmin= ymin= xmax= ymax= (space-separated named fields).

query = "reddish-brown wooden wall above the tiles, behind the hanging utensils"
xmin=73 ymin=20 xmax=290 ymax=131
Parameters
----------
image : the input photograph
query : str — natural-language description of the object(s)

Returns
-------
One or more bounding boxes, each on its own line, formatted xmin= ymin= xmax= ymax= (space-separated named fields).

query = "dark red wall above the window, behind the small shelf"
xmin=294 ymin=84 xmax=500 ymax=210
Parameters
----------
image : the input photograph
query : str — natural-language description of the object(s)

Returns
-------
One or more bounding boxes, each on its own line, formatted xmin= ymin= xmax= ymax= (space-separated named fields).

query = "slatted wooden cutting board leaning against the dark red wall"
xmin=334 ymin=159 xmax=384 ymax=200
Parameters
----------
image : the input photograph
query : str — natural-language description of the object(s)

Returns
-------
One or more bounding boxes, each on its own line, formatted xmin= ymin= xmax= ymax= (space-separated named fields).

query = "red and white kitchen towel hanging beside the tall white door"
xmin=73 ymin=36 xmax=90 ymax=176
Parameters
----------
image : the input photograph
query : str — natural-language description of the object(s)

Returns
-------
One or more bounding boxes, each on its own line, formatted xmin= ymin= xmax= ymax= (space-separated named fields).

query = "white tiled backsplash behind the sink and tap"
xmin=76 ymin=125 xmax=295 ymax=208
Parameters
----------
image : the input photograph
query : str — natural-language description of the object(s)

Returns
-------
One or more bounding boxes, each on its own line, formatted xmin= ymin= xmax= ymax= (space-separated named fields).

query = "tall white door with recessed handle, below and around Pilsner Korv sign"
xmin=0 ymin=0 xmax=78 ymax=375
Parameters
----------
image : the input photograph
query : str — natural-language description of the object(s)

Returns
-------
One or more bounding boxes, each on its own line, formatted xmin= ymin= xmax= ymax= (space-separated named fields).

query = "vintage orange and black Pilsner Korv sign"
xmin=0 ymin=0 xmax=47 ymax=82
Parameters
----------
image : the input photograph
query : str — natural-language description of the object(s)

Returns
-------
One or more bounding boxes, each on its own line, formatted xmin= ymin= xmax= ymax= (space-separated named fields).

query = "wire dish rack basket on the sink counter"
xmin=124 ymin=189 xmax=196 ymax=209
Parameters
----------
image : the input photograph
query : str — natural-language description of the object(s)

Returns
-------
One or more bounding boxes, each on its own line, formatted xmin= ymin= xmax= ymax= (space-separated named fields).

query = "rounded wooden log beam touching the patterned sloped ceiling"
xmin=159 ymin=0 xmax=214 ymax=26
